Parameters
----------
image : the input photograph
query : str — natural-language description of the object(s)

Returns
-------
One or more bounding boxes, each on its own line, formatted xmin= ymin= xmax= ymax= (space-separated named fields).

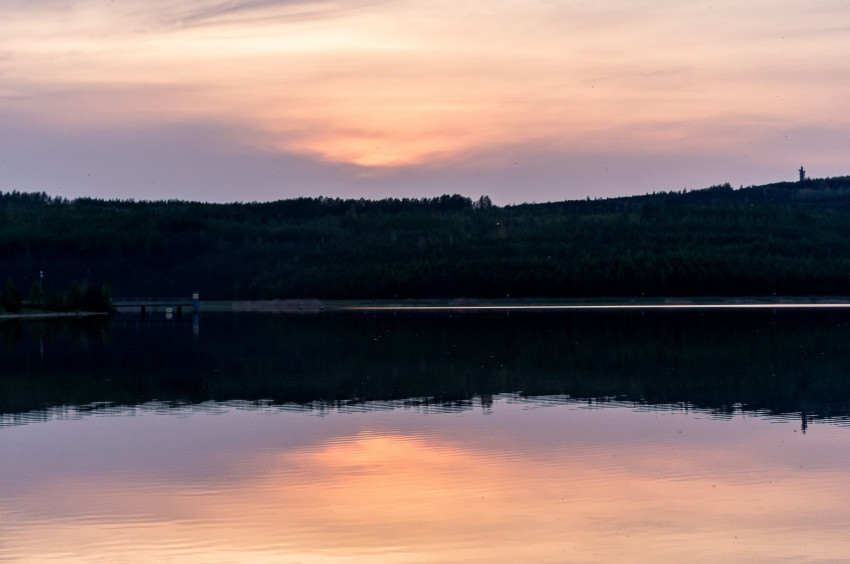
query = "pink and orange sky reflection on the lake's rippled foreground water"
xmin=0 ymin=396 xmax=850 ymax=562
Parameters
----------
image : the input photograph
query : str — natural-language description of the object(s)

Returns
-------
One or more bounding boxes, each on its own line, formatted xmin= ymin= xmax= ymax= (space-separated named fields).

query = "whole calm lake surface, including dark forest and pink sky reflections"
xmin=0 ymin=311 xmax=850 ymax=562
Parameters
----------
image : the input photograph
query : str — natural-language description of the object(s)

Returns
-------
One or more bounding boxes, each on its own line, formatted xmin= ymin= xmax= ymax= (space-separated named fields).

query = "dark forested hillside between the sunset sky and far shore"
xmin=0 ymin=177 xmax=850 ymax=302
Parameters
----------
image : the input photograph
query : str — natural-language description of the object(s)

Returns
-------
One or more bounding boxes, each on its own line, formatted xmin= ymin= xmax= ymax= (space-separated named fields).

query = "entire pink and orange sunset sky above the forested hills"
xmin=0 ymin=0 xmax=850 ymax=204
